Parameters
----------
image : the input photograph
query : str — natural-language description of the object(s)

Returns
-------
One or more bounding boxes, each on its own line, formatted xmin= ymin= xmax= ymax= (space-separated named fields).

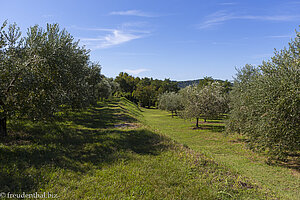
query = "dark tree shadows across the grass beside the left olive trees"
xmin=0 ymin=99 xmax=167 ymax=192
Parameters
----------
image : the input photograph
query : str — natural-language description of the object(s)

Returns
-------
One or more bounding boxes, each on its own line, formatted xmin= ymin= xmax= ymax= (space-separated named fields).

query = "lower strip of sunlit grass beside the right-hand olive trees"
xmin=143 ymin=109 xmax=300 ymax=199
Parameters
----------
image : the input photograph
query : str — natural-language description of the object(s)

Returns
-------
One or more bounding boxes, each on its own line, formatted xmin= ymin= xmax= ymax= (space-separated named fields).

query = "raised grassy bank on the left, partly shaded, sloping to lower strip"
xmin=0 ymin=99 xmax=273 ymax=199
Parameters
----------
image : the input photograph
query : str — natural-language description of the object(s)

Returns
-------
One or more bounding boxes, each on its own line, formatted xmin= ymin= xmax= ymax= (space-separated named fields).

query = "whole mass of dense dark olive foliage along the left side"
xmin=0 ymin=22 xmax=110 ymax=135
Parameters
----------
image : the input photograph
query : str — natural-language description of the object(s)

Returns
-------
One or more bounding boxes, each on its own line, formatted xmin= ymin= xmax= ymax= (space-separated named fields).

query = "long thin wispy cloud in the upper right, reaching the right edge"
xmin=197 ymin=11 xmax=300 ymax=29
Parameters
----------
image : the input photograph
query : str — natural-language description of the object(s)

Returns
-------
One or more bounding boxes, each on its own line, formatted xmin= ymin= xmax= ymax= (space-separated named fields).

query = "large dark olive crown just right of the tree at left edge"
xmin=24 ymin=24 xmax=101 ymax=118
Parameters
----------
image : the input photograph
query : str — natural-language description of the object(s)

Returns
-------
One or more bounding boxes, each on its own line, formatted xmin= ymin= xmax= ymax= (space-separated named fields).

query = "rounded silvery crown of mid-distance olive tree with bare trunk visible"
xmin=180 ymin=82 xmax=227 ymax=120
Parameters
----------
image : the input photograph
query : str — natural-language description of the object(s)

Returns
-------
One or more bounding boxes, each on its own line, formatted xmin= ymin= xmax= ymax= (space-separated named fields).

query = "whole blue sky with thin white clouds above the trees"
xmin=0 ymin=0 xmax=300 ymax=80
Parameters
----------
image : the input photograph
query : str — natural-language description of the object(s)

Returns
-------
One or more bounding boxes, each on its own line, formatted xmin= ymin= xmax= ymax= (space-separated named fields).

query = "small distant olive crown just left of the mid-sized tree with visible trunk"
xmin=158 ymin=92 xmax=183 ymax=116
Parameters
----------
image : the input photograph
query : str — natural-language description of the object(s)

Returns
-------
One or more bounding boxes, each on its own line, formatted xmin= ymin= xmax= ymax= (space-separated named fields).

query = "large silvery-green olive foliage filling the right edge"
xmin=227 ymin=29 xmax=300 ymax=157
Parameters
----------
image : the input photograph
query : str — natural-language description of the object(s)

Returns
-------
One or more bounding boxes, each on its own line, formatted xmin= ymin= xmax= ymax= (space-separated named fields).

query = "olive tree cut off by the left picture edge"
xmin=0 ymin=21 xmax=34 ymax=136
